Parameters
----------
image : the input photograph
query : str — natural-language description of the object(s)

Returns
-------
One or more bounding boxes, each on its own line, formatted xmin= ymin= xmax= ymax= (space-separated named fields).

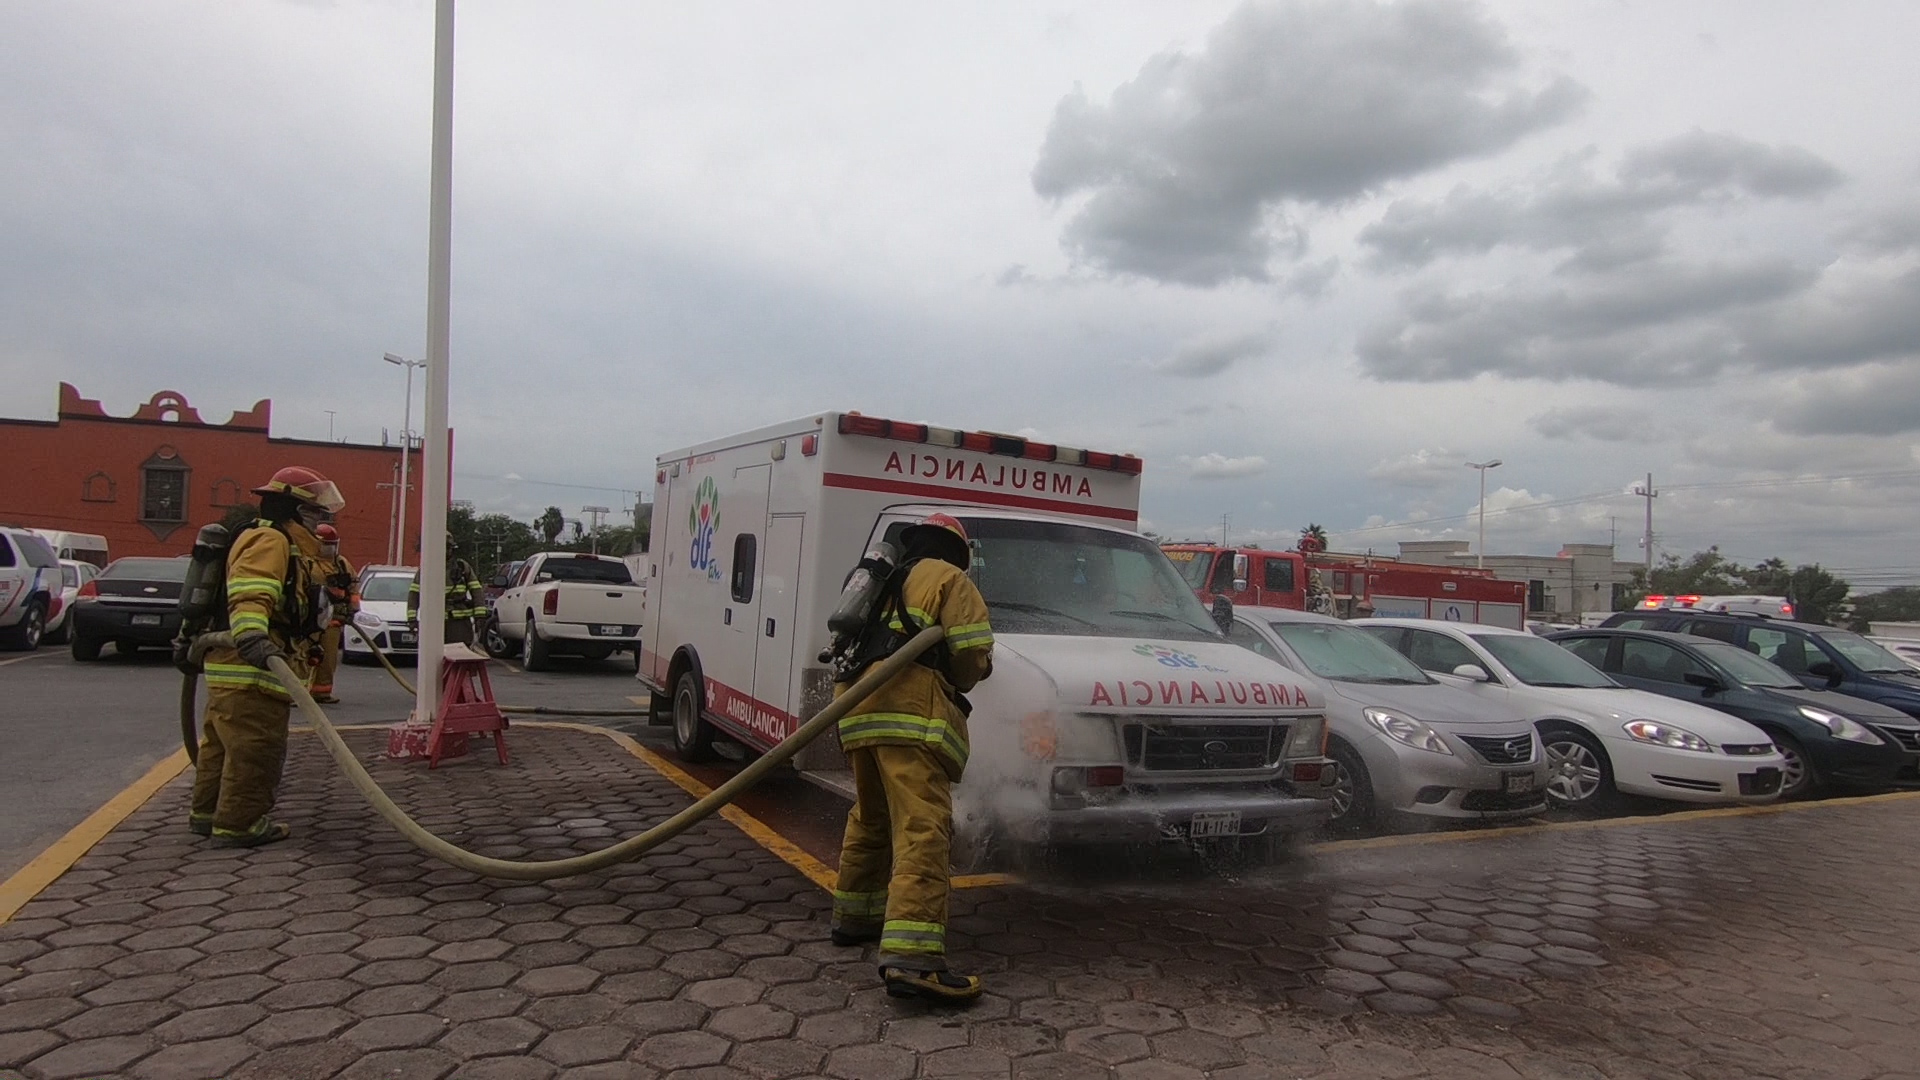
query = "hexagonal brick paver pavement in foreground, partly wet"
xmin=0 ymin=730 xmax=1920 ymax=1080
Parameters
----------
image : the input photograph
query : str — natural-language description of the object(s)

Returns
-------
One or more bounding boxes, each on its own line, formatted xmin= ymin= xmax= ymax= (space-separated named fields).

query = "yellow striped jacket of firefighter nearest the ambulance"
xmin=833 ymin=559 xmax=993 ymax=780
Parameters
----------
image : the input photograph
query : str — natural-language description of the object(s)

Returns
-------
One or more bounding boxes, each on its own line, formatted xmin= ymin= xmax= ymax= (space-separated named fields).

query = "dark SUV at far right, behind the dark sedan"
xmin=1603 ymin=611 xmax=1920 ymax=719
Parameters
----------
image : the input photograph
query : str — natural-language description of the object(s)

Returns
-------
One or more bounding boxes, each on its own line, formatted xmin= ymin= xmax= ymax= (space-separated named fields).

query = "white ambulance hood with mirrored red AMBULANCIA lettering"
xmin=983 ymin=634 xmax=1325 ymax=717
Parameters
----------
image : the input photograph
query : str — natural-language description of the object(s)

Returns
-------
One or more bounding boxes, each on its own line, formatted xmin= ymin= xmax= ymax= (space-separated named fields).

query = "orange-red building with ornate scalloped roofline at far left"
xmin=0 ymin=382 xmax=405 ymax=567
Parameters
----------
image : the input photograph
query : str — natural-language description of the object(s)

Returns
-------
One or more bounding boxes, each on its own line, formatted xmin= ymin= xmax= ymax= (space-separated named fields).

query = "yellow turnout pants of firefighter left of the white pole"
xmin=192 ymin=686 xmax=288 ymax=838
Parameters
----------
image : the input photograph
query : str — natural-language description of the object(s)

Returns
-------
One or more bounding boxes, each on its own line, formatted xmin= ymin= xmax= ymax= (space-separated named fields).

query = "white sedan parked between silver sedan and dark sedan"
xmin=1356 ymin=619 xmax=1786 ymax=809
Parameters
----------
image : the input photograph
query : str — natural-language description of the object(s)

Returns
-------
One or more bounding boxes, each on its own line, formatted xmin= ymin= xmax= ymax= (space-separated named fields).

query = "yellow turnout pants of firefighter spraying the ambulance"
xmin=833 ymin=746 xmax=954 ymax=970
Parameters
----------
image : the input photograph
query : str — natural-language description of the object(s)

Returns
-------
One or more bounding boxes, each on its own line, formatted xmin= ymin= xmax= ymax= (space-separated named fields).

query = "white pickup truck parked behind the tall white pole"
xmin=488 ymin=552 xmax=645 ymax=671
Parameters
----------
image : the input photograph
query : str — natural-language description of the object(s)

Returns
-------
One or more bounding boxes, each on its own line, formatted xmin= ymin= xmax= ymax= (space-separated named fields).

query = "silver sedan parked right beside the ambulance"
xmin=1231 ymin=607 xmax=1548 ymax=828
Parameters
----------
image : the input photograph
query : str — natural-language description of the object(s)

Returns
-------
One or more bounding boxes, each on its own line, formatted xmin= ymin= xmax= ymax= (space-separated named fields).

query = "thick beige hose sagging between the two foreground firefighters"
xmin=180 ymin=626 xmax=945 ymax=882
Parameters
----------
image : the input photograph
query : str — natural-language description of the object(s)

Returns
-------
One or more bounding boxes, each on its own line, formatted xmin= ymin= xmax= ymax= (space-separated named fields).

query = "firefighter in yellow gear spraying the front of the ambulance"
xmin=833 ymin=515 xmax=993 ymax=1001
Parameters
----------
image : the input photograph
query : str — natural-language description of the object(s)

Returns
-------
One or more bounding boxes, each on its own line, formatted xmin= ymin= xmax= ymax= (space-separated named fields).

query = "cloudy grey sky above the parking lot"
xmin=0 ymin=0 xmax=1920 ymax=582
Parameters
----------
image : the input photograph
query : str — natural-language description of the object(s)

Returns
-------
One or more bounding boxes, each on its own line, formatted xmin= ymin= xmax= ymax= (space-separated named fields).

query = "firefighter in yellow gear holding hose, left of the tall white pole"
xmin=188 ymin=465 xmax=346 ymax=847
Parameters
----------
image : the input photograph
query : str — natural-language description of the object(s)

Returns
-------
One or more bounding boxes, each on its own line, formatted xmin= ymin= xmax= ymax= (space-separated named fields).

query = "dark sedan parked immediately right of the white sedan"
xmin=1548 ymin=628 xmax=1920 ymax=798
